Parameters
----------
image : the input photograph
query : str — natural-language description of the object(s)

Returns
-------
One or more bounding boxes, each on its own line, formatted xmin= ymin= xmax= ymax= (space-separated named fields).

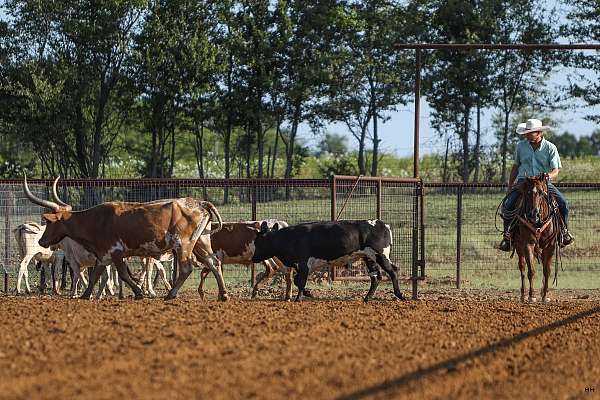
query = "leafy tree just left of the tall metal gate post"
xmin=324 ymin=0 xmax=410 ymax=175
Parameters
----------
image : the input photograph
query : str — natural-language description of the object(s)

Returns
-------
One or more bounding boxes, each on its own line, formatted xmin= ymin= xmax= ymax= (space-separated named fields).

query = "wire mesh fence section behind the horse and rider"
xmin=425 ymin=183 xmax=600 ymax=287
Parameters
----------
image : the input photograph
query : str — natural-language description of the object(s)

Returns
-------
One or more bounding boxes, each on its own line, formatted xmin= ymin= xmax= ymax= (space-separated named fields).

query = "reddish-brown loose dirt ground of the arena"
xmin=0 ymin=287 xmax=600 ymax=399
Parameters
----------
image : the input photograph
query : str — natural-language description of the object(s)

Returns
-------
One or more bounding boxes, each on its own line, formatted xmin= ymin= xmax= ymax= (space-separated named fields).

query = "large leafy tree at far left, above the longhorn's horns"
xmin=1 ymin=0 xmax=145 ymax=178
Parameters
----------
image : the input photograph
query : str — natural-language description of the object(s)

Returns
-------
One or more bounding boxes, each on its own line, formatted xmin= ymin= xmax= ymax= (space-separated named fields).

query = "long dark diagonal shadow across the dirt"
xmin=337 ymin=306 xmax=600 ymax=400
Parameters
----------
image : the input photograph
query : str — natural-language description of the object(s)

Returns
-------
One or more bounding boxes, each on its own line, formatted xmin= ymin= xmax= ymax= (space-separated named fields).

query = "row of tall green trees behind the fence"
xmin=0 ymin=0 xmax=600 ymax=188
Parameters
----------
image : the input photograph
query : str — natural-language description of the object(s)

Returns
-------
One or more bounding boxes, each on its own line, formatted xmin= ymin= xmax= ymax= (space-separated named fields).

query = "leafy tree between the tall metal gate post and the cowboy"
xmin=424 ymin=0 xmax=497 ymax=182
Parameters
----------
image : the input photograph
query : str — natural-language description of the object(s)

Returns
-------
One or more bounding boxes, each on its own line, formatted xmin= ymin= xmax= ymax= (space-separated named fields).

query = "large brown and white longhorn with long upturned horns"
xmin=23 ymin=177 xmax=227 ymax=300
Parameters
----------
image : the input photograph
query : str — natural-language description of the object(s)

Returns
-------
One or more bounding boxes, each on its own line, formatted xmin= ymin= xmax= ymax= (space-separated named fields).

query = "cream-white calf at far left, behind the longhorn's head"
xmin=13 ymin=222 xmax=63 ymax=294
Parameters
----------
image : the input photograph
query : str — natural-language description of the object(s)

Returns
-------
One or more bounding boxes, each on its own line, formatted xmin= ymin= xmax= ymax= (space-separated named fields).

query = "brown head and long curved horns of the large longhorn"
xmin=23 ymin=176 xmax=72 ymax=247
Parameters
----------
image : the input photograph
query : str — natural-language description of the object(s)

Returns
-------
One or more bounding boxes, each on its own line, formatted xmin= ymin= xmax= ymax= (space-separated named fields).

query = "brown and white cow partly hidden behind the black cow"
xmin=194 ymin=220 xmax=292 ymax=300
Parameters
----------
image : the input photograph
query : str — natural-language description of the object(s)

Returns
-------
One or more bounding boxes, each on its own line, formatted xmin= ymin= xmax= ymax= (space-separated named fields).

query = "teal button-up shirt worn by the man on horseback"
xmin=515 ymin=138 xmax=562 ymax=179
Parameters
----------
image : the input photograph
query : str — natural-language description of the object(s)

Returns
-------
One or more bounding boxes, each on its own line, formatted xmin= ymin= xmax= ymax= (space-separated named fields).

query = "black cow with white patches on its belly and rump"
xmin=252 ymin=220 xmax=404 ymax=302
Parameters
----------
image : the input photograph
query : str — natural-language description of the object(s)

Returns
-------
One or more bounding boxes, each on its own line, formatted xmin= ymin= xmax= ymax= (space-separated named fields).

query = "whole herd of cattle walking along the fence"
xmin=14 ymin=177 xmax=403 ymax=301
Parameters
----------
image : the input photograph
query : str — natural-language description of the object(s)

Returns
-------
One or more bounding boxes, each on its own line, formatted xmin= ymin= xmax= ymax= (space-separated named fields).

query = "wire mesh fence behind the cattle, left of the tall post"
xmin=0 ymin=178 xmax=414 ymax=294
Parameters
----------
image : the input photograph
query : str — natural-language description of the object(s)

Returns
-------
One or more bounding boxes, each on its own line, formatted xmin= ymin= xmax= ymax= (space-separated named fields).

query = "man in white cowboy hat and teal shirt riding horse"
xmin=498 ymin=118 xmax=574 ymax=251
